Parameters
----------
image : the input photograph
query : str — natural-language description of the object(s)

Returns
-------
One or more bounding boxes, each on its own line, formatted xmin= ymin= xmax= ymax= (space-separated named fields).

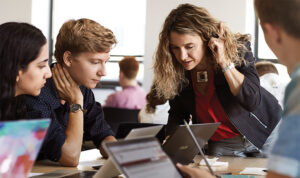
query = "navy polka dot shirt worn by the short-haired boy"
xmin=25 ymin=78 xmax=114 ymax=161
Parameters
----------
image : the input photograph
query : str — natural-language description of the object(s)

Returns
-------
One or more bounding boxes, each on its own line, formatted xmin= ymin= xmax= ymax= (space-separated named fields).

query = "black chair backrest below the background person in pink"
xmin=103 ymin=107 xmax=140 ymax=133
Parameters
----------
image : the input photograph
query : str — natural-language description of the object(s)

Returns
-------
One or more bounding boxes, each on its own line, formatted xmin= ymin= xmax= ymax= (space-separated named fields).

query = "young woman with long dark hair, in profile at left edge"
xmin=0 ymin=22 xmax=51 ymax=120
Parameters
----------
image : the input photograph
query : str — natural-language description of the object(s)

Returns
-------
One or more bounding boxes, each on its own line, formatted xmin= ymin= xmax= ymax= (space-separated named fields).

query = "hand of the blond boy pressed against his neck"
xmin=52 ymin=64 xmax=83 ymax=106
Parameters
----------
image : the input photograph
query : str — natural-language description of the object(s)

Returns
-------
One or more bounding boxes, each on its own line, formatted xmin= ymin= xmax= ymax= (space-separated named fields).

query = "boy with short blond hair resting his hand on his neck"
xmin=26 ymin=19 xmax=116 ymax=166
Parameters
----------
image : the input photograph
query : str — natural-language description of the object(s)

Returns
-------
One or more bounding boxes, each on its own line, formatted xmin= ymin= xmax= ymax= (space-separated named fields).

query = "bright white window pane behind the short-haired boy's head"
xmin=52 ymin=0 xmax=146 ymax=56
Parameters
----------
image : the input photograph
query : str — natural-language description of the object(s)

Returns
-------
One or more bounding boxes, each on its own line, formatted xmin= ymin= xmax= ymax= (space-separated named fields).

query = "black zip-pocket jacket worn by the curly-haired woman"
xmin=167 ymin=44 xmax=281 ymax=148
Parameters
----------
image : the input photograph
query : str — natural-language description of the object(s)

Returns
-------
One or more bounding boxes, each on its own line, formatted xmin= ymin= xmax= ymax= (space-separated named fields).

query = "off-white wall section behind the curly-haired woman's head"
xmin=143 ymin=0 xmax=249 ymax=91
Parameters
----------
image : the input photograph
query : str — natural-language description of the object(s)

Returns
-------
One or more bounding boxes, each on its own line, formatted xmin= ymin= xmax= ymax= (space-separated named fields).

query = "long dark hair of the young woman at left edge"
xmin=0 ymin=22 xmax=47 ymax=120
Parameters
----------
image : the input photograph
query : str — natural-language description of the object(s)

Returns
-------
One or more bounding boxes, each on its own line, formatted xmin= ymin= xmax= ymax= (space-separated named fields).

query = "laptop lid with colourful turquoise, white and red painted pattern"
xmin=0 ymin=119 xmax=50 ymax=178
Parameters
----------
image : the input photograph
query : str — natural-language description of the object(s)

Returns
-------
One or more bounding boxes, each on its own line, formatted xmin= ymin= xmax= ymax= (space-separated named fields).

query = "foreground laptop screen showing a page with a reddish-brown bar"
xmin=103 ymin=137 xmax=182 ymax=178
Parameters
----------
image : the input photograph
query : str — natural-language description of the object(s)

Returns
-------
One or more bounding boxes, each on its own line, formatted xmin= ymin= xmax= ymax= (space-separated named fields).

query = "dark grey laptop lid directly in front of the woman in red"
xmin=162 ymin=123 xmax=220 ymax=164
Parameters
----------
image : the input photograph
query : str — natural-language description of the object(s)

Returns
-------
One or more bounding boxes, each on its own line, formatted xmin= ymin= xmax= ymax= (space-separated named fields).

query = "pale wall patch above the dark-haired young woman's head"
xmin=0 ymin=0 xmax=31 ymax=24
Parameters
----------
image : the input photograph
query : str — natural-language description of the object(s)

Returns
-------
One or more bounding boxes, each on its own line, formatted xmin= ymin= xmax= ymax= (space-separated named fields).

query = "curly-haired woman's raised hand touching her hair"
xmin=208 ymin=23 xmax=231 ymax=69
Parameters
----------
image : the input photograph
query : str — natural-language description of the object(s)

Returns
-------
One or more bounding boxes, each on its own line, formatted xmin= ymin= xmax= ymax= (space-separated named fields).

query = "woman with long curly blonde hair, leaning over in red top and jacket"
xmin=151 ymin=4 xmax=280 ymax=156
